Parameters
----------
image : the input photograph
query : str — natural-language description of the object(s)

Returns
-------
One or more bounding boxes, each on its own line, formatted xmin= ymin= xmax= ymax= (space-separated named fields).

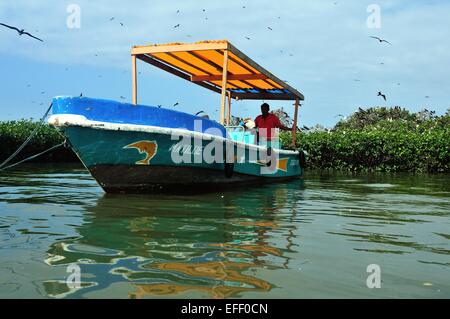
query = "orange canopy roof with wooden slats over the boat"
xmin=131 ymin=40 xmax=304 ymax=100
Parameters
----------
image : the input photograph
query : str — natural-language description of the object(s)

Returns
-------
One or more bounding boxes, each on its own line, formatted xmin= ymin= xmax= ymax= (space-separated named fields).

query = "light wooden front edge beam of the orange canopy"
xmin=131 ymin=41 xmax=228 ymax=55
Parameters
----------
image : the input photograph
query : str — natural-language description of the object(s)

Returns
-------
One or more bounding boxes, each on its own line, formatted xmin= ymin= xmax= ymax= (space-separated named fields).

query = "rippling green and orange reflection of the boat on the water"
xmin=47 ymin=182 xmax=302 ymax=298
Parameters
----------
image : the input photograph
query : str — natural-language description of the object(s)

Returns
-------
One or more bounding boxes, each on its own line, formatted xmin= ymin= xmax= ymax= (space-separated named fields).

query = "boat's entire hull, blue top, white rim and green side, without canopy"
xmin=51 ymin=99 xmax=303 ymax=193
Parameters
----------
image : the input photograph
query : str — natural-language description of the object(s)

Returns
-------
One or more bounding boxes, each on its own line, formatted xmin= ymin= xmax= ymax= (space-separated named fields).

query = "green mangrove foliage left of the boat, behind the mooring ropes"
xmin=0 ymin=120 xmax=78 ymax=163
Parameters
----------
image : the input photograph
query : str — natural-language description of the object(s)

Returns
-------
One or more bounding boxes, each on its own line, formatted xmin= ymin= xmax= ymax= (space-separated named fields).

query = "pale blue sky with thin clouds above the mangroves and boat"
xmin=0 ymin=0 xmax=450 ymax=126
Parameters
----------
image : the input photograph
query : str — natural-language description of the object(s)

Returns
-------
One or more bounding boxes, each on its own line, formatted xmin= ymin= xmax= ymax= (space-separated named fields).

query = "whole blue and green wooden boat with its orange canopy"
xmin=49 ymin=41 xmax=304 ymax=192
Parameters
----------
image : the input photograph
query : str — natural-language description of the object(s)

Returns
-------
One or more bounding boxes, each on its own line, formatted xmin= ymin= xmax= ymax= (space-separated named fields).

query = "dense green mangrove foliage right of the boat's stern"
xmin=281 ymin=108 xmax=450 ymax=172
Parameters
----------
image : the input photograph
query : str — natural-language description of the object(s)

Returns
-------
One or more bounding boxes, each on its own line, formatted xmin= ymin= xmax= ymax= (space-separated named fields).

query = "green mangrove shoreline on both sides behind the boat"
xmin=0 ymin=108 xmax=450 ymax=173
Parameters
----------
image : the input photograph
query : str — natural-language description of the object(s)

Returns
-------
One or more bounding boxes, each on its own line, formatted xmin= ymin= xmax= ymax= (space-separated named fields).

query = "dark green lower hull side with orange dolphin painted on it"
xmin=59 ymin=126 xmax=304 ymax=193
